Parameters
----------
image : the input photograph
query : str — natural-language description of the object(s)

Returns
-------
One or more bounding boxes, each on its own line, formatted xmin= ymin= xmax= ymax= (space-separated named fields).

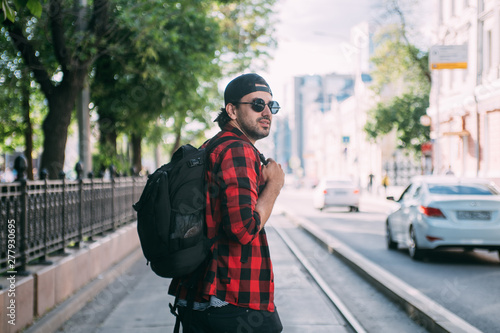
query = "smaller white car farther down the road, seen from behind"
xmin=313 ymin=179 xmax=360 ymax=212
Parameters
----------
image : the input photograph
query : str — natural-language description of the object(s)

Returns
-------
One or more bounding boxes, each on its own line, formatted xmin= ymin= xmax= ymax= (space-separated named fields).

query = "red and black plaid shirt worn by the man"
xmin=169 ymin=125 xmax=274 ymax=311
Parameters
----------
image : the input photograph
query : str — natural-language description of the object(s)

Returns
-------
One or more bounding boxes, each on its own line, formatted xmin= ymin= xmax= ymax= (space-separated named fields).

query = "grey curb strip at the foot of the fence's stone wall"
xmin=24 ymin=247 xmax=143 ymax=333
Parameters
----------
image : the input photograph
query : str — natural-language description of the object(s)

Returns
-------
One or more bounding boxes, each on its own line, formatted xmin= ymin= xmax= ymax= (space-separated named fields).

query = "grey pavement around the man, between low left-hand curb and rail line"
xmin=45 ymin=214 xmax=348 ymax=333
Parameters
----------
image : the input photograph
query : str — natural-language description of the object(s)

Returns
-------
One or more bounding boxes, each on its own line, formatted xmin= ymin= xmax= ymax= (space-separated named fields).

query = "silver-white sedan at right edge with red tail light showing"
xmin=386 ymin=176 xmax=500 ymax=260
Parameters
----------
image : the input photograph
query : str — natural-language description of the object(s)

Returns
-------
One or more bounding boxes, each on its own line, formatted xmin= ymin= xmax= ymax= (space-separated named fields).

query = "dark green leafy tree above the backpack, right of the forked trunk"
xmin=91 ymin=1 xmax=219 ymax=170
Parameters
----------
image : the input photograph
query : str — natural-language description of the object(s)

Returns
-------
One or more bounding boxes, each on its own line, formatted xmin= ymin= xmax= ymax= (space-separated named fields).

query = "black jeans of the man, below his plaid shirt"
xmin=179 ymin=304 xmax=283 ymax=333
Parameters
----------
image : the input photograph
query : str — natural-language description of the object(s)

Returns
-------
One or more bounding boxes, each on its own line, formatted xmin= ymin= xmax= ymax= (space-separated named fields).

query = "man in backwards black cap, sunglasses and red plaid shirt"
xmin=169 ymin=74 xmax=285 ymax=333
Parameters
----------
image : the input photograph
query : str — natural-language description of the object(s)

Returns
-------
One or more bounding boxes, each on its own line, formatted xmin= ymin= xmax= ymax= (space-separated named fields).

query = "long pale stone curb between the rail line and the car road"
xmin=283 ymin=211 xmax=481 ymax=333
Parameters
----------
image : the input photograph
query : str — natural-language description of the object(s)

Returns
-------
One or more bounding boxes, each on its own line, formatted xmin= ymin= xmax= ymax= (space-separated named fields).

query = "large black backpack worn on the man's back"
xmin=133 ymin=136 xmax=234 ymax=278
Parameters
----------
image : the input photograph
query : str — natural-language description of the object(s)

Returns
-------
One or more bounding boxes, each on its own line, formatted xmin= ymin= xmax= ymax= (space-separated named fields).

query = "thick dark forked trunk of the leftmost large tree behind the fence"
xmin=2 ymin=0 xmax=108 ymax=179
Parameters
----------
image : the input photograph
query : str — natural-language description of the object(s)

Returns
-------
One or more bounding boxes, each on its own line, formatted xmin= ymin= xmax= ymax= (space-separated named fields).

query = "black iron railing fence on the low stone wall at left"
xmin=0 ymin=160 xmax=146 ymax=273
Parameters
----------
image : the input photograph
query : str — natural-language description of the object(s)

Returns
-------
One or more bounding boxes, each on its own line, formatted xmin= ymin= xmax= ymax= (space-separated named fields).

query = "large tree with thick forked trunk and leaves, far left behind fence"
xmin=2 ymin=0 xmax=110 ymax=178
